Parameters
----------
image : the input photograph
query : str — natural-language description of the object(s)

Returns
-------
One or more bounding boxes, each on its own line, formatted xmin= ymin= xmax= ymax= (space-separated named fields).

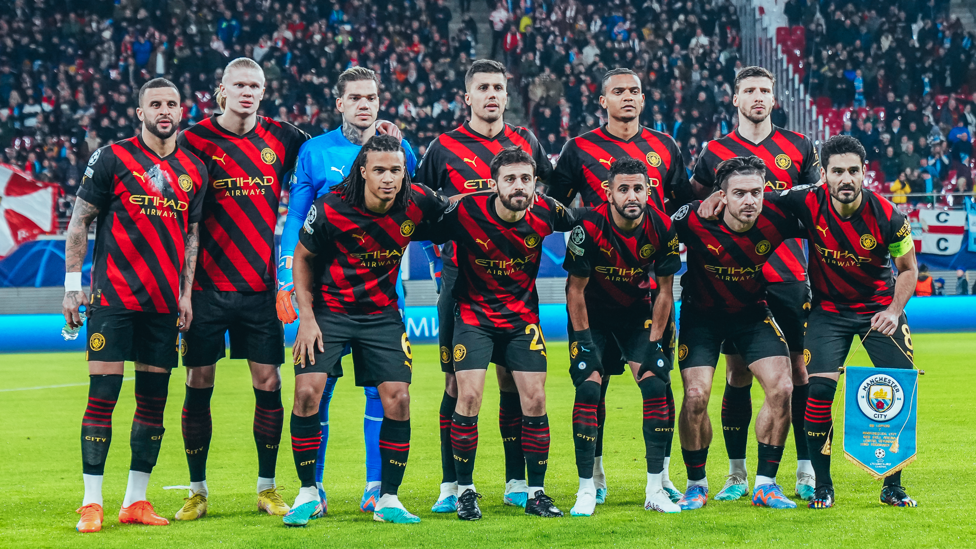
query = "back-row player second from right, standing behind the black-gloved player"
xmin=549 ymin=68 xmax=694 ymax=503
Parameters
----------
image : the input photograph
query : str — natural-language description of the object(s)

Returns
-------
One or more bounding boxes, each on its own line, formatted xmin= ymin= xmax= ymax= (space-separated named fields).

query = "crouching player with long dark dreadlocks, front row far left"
xmin=284 ymin=135 xmax=449 ymax=526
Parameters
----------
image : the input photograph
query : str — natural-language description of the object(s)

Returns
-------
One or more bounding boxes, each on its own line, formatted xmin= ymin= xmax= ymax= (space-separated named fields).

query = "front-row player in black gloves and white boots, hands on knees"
xmin=563 ymin=158 xmax=681 ymax=516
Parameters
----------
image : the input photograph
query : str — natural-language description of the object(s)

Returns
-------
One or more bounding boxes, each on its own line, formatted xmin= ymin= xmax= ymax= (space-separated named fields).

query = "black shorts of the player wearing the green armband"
xmin=803 ymin=307 xmax=915 ymax=374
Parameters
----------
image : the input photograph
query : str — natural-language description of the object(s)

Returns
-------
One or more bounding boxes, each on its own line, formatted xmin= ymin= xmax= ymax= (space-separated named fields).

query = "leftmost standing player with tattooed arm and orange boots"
xmin=63 ymin=78 xmax=207 ymax=532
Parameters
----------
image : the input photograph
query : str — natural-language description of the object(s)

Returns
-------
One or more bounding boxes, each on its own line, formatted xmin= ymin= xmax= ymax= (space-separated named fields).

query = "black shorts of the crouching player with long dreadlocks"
xmin=304 ymin=307 xmax=413 ymax=387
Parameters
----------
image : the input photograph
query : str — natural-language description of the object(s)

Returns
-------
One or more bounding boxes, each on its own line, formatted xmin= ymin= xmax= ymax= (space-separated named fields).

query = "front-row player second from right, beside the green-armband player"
xmin=672 ymin=156 xmax=801 ymax=511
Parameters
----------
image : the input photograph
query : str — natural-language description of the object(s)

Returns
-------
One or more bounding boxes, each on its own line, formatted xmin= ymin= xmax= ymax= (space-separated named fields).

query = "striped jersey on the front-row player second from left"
xmin=430 ymin=193 xmax=582 ymax=329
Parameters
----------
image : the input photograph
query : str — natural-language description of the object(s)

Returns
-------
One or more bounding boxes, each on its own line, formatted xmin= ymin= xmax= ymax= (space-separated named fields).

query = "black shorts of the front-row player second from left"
xmin=451 ymin=319 xmax=547 ymax=372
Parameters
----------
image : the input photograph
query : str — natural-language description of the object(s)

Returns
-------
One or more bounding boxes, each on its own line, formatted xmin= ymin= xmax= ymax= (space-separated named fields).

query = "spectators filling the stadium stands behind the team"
xmin=0 ymin=0 xmax=976 ymax=225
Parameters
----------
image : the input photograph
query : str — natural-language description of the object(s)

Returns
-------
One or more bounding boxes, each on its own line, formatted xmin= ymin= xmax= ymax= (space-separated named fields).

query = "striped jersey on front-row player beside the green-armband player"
xmin=672 ymin=199 xmax=803 ymax=313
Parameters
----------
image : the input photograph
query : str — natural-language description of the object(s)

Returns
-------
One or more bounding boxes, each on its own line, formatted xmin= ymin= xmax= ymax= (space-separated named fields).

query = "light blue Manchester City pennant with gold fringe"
xmin=844 ymin=367 xmax=919 ymax=479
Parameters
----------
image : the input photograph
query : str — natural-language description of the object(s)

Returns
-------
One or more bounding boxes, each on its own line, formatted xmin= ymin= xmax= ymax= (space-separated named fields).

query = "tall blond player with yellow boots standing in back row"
xmin=176 ymin=57 xmax=308 ymax=520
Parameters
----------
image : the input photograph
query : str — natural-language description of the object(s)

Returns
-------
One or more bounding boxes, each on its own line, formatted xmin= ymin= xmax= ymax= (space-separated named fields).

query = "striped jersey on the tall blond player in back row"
xmin=179 ymin=115 xmax=309 ymax=292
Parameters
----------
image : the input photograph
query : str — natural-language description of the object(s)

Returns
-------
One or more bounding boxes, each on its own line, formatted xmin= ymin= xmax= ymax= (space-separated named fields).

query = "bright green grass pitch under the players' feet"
xmin=0 ymin=334 xmax=976 ymax=548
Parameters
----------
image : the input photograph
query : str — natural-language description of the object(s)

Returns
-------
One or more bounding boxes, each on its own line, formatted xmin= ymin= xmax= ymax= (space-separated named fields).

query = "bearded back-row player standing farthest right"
xmin=692 ymin=67 xmax=820 ymax=501
